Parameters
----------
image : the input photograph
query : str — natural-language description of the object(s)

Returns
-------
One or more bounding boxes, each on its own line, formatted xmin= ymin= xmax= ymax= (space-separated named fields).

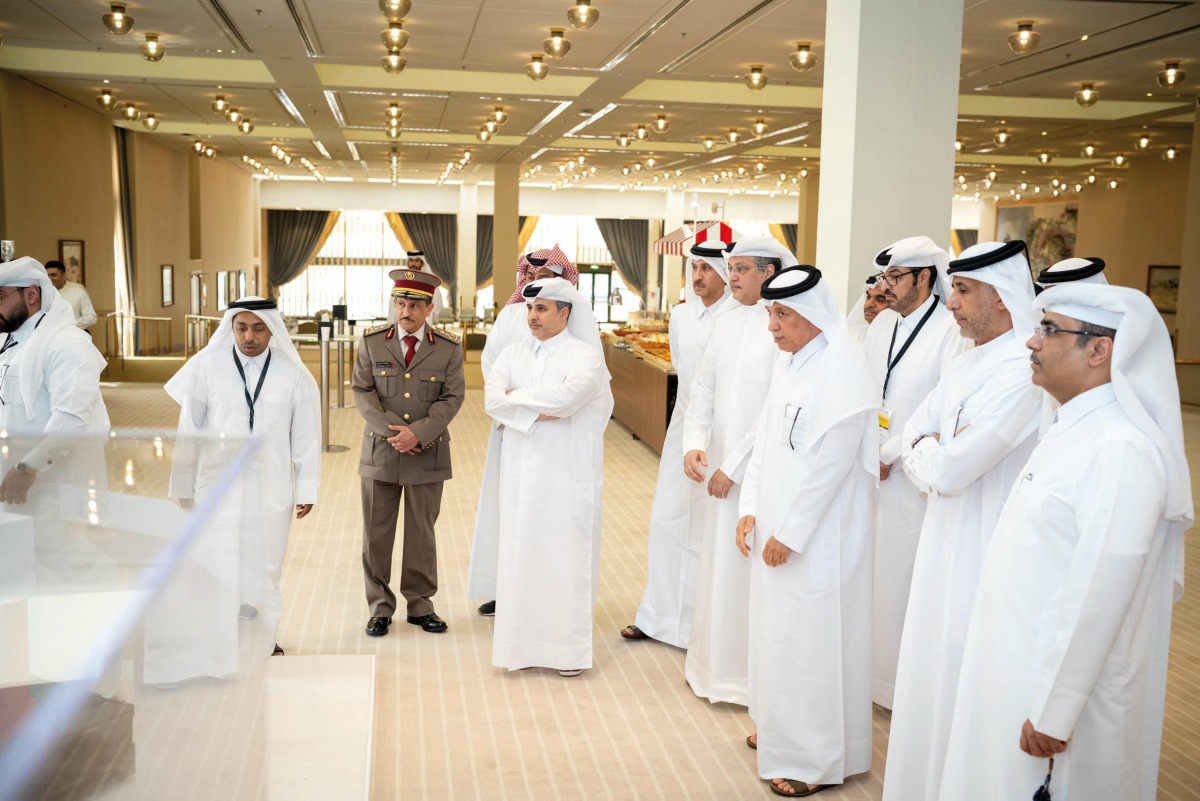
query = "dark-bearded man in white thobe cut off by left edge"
xmin=0 ymin=257 xmax=108 ymax=504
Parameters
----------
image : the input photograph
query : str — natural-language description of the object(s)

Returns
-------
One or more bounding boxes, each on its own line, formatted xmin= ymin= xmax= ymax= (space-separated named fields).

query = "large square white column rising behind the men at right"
xmin=817 ymin=0 xmax=962 ymax=306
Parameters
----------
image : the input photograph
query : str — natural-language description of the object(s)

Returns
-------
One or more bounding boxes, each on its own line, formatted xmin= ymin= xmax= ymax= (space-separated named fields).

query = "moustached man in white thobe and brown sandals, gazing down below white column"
xmin=737 ymin=266 xmax=878 ymax=797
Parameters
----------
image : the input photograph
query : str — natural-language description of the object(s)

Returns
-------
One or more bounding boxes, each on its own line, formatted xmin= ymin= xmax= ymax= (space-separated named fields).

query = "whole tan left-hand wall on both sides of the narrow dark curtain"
xmin=0 ymin=73 xmax=260 ymax=349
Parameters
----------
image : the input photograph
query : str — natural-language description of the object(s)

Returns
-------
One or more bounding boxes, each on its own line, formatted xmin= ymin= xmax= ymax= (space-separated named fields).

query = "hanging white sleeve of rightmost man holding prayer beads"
xmin=1014 ymin=441 xmax=1166 ymax=740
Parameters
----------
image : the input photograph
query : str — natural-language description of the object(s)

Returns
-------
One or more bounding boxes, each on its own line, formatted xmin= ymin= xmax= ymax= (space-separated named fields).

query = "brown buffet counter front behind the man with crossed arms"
xmin=604 ymin=335 xmax=678 ymax=456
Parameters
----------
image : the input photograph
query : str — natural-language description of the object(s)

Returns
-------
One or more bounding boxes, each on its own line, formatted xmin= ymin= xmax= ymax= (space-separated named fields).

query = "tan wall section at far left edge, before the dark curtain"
xmin=0 ymin=73 xmax=116 ymax=326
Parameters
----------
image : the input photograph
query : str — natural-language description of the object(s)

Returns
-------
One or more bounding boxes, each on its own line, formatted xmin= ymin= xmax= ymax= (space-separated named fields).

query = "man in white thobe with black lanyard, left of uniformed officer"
xmin=164 ymin=297 xmax=322 ymax=661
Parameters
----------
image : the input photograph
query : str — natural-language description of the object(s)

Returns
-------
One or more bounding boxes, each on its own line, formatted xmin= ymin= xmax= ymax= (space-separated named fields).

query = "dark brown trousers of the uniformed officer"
xmin=360 ymin=478 xmax=443 ymax=618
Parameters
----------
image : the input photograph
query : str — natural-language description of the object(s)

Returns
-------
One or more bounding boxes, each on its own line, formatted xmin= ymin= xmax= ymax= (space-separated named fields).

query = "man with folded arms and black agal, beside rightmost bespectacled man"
xmin=883 ymin=241 xmax=1042 ymax=801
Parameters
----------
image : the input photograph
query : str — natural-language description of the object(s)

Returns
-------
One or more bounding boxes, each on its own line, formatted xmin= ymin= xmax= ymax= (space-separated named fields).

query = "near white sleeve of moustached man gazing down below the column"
xmin=772 ymin=412 xmax=874 ymax=554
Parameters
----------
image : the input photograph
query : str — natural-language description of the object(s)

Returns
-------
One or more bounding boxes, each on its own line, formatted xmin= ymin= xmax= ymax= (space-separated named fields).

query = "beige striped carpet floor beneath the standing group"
xmin=106 ymin=376 xmax=1200 ymax=801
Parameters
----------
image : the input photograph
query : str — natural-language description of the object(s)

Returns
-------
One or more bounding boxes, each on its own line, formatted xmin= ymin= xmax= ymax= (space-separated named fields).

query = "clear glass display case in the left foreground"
xmin=0 ymin=432 xmax=278 ymax=801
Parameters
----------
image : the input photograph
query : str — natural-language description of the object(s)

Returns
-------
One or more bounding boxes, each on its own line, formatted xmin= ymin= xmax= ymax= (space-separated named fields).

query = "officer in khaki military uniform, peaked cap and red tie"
xmin=353 ymin=270 xmax=466 ymax=637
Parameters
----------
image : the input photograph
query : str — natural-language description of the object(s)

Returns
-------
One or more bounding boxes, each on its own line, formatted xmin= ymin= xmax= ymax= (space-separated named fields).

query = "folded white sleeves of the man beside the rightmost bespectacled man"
xmin=902 ymin=371 xmax=1042 ymax=495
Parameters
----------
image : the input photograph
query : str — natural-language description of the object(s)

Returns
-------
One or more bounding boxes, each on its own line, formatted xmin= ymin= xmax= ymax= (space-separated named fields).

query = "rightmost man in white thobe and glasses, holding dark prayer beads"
xmin=941 ymin=283 xmax=1195 ymax=801
